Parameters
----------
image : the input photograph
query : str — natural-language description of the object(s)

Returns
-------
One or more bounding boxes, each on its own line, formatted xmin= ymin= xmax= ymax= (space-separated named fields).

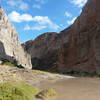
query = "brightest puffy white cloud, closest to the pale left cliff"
xmin=8 ymin=11 xmax=33 ymax=23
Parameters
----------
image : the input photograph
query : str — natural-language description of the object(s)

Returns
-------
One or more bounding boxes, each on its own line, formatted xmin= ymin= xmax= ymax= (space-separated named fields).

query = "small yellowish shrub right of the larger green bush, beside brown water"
xmin=36 ymin=88 xmax=57 ymax=99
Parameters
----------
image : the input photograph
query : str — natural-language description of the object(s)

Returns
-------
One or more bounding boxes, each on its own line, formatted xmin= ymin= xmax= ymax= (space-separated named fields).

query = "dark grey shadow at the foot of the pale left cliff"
xmin=0 ymin=41 xmax=17 ymax=64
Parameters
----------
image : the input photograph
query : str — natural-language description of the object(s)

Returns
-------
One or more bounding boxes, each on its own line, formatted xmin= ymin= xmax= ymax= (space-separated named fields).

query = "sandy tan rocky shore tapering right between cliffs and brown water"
xmin=0 ymin=65 xmax=74 ymax=84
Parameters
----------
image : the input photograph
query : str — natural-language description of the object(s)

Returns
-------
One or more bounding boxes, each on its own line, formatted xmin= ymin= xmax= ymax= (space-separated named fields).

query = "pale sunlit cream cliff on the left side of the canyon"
xmin=0 ymin=7 xmax=32 ymax=68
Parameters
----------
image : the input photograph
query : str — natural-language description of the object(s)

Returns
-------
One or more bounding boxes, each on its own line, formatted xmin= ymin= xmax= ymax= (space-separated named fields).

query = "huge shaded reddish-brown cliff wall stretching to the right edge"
xmin=25 ymin=0 xmax=100 ymax=73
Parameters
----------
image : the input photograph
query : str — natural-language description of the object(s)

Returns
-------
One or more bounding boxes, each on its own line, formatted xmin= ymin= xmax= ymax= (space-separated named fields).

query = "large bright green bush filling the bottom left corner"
xmin=0 ymin=82 xmax=38 ymax=100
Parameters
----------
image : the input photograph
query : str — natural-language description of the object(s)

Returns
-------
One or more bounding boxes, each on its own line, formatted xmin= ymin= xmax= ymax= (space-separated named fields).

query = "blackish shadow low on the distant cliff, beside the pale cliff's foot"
xmin=31 ymin=50 xmax=59 ymax=72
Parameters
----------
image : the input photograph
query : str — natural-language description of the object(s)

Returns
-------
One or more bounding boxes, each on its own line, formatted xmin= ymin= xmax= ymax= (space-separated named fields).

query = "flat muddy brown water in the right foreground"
xmin=38 ymin=78 xmax=100 ymax=100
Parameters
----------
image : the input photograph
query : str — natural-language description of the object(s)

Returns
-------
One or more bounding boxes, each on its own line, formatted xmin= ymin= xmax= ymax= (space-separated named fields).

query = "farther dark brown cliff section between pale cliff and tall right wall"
xmin=23 ymin=33 xmax=59 ymax=70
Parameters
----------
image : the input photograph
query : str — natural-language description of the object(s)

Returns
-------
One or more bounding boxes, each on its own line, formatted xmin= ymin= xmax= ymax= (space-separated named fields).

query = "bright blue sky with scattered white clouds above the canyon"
xmin=0 ymin=0 xmax=87 ymax=42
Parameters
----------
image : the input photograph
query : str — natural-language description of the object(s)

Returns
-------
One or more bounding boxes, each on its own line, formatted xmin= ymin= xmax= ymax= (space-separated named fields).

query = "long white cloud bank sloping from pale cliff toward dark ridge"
xmin=8 ymin=11 xmax=59 ymax=30
